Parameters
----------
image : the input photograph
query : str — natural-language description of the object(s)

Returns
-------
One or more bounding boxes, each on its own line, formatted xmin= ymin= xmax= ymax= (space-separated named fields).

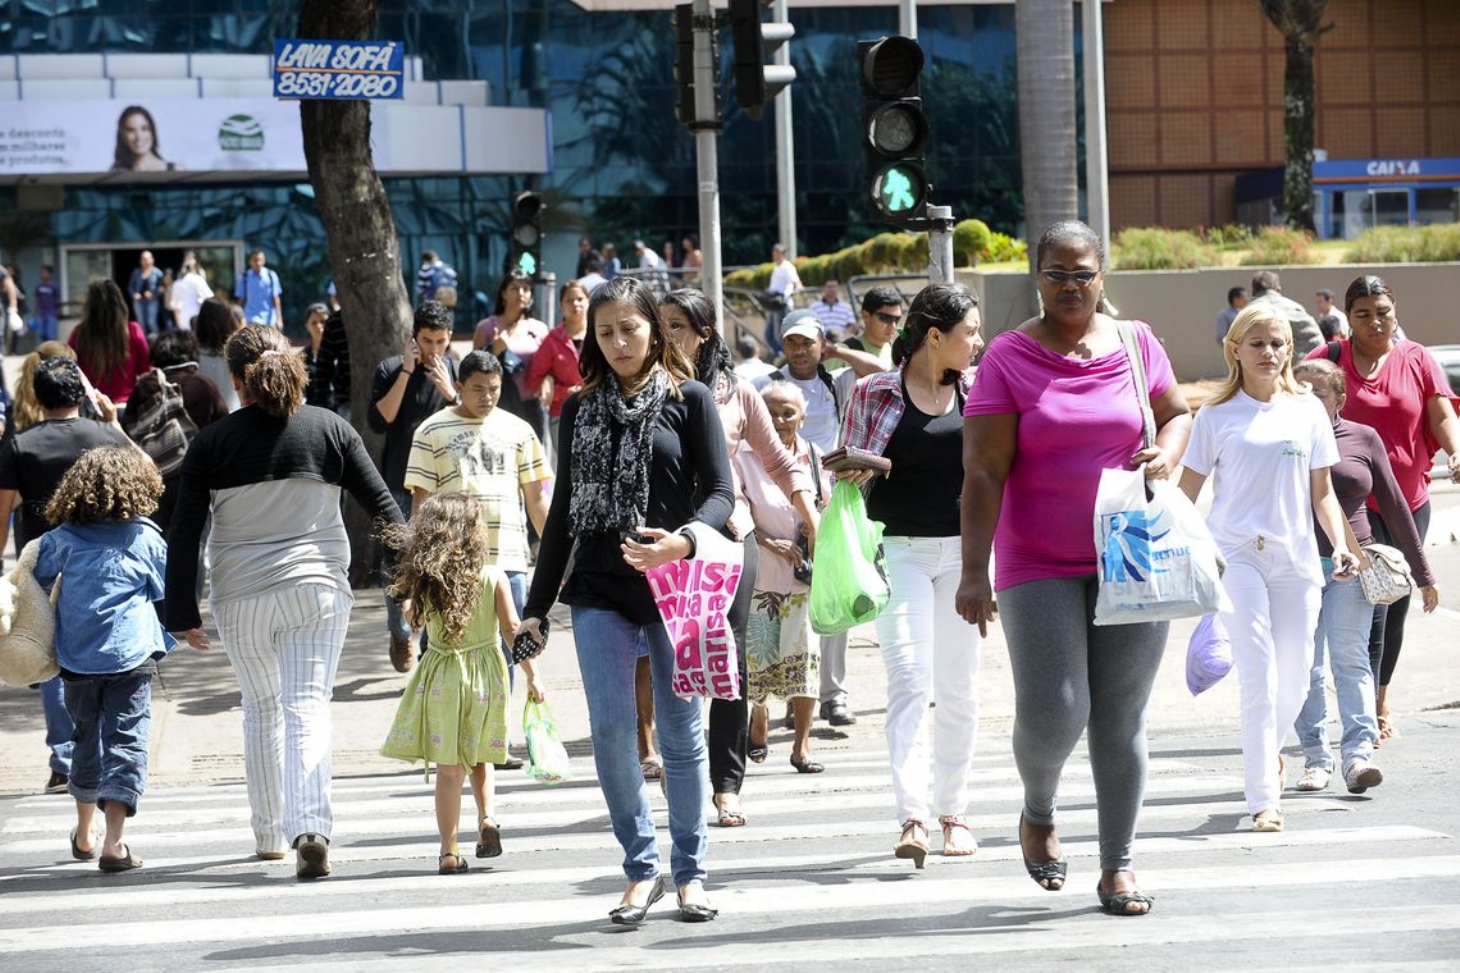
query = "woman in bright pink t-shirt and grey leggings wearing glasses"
xmin=958 ymin=221 xmax=1191 ymax=916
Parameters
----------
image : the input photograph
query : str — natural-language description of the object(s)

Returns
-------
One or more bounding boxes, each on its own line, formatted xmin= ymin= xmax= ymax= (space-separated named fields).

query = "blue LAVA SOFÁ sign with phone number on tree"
xmin=274 ymin=39 xmax=406 ymax=101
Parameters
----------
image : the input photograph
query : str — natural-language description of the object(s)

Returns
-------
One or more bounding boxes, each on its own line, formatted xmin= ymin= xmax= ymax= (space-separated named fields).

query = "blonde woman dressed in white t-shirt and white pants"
xmin=1181 ymin=305 xmax=1358 ymax=831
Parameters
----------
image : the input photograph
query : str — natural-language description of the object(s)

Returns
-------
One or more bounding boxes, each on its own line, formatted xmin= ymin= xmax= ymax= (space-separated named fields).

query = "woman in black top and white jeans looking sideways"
xmin=842 ymin=283 xmax=983 ymax=868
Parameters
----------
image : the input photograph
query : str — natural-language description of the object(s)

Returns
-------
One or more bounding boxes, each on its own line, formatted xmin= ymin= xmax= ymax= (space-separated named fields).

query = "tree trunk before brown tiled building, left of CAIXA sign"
xmin=1257 ymin=0 xmax=1333 ymax=234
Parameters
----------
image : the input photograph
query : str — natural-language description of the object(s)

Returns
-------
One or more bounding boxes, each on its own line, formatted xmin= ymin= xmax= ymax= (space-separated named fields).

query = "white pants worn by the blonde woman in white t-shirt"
xmin=1222 ymin=539 xmax=1323 ymax=814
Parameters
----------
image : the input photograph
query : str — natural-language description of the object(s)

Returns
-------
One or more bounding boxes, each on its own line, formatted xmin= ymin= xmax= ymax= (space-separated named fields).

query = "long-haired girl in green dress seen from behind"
xmin=381 ymin=492 xmax=543 ymax=875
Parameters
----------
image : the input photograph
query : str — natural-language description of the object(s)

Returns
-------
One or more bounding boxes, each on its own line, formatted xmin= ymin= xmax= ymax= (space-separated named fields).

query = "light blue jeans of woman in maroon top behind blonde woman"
xmin=1292 ymin=558 xmax=1378 ymax=771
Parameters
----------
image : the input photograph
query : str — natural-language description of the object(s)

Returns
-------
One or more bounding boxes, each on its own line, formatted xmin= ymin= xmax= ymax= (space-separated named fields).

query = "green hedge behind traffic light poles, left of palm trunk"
xmin=726 ymin=219 xmax=1028 ymax=291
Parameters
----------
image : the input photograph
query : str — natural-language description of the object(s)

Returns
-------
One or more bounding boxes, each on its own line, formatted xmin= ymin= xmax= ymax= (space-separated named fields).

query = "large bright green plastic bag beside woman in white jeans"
xmin=810 ymin=479 xmax=888 ymax=636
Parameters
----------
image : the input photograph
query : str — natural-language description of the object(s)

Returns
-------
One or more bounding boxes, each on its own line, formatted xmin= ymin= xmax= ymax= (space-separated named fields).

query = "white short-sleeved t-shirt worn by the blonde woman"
xmin=1181 ymin=392 xmax=1339 ymax=576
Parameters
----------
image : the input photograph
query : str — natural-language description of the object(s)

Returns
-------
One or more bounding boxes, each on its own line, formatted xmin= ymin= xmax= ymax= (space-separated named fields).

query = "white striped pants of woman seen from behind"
xmin=213 ymin=584 xmax=355 ymax=852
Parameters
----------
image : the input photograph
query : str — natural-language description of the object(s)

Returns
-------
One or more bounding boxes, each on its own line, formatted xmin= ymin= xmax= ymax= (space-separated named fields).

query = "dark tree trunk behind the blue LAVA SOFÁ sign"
xmin=299 ymin=0 xmax=410 ymax=578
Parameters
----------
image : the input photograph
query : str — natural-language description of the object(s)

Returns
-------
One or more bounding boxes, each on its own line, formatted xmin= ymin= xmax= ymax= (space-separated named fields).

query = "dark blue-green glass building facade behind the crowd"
xmin=0 ymin=0 xmax=1022 ymax=320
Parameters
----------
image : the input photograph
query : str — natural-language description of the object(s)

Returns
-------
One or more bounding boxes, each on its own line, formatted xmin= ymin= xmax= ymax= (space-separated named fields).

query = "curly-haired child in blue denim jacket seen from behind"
xmin=35 ymin=446 xmax=177 ymax=872
